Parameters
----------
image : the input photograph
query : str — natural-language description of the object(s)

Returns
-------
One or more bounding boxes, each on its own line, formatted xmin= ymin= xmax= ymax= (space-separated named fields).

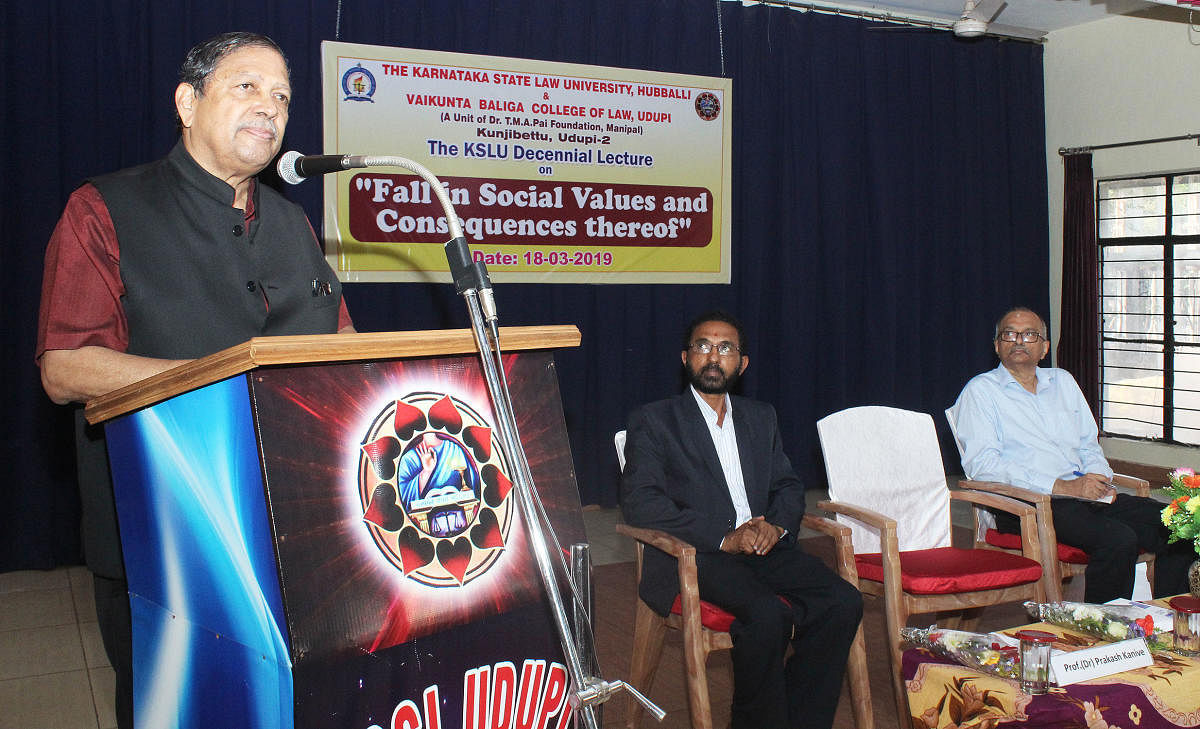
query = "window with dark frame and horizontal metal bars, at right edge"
xmin=1096 ymin=171 xmax=1200 ymax=445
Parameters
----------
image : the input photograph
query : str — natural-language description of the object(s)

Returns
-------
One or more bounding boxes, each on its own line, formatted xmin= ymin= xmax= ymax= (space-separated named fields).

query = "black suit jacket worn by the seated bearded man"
xmin=620 ymin=387 xmax=804 ymax=615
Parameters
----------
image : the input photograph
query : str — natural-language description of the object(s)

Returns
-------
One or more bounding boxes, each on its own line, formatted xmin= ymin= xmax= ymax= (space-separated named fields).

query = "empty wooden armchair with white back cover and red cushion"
xmin=817 ymin=406 xmax=1046 ymax=725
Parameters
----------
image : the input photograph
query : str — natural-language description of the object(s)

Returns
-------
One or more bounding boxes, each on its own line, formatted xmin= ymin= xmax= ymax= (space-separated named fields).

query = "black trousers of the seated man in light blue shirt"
xmin=996 ymin=494 xmax=1195 ymax=603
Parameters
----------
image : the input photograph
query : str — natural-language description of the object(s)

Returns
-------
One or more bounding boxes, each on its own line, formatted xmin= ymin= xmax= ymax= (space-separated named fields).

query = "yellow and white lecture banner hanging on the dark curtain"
xmin=322 ymin=41 xmax=732 ymax=283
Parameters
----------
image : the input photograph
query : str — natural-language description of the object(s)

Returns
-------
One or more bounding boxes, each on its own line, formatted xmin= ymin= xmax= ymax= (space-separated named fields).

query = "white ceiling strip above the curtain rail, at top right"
xmin=792 ymin=0 xmax=1200 ymax=32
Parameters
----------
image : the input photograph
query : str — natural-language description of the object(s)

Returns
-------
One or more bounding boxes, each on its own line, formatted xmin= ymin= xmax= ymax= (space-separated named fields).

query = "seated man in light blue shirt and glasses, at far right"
xmin=952 ymin=308 xmax=1192 ymax=603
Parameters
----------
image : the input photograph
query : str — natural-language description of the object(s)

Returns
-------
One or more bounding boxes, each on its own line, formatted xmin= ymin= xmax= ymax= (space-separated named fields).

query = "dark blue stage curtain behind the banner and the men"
xmin=0 ymin=0 xmax=1049 ymax=571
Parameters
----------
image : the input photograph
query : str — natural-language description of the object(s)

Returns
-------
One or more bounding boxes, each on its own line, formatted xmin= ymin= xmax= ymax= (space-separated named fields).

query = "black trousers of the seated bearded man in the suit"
xmin=696 ymin=543 xmax=863 ymax=729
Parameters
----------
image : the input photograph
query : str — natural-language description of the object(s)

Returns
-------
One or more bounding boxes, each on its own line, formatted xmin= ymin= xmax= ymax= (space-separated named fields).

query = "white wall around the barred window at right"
xmin=1044 ymin=13 xmax=1200 ymax=468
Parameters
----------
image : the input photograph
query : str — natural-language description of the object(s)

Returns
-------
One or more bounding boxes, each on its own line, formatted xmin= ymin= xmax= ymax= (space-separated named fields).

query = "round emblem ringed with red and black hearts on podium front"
xmin=359 ymin=392 xmax=512 ymax=588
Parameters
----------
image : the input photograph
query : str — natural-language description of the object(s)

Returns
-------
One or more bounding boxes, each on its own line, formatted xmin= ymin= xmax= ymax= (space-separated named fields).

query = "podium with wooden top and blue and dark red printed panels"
xmin=86 ymin=326 xmax=584 ymax=729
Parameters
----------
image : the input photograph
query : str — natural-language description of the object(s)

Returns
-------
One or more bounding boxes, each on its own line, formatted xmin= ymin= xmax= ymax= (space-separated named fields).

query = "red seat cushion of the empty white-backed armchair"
xmin=854 ymin=547 xmax=1042 ymax=595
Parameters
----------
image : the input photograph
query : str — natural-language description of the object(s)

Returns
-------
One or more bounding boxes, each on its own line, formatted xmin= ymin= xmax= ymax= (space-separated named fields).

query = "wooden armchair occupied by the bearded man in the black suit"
xmin=617 ymin=514 xmax=875 ymax=729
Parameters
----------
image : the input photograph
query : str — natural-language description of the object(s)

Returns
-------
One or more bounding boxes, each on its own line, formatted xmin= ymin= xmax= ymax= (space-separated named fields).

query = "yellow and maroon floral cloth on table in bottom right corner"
xmin=904 ymin=613 xmax=1200 ymax=729
